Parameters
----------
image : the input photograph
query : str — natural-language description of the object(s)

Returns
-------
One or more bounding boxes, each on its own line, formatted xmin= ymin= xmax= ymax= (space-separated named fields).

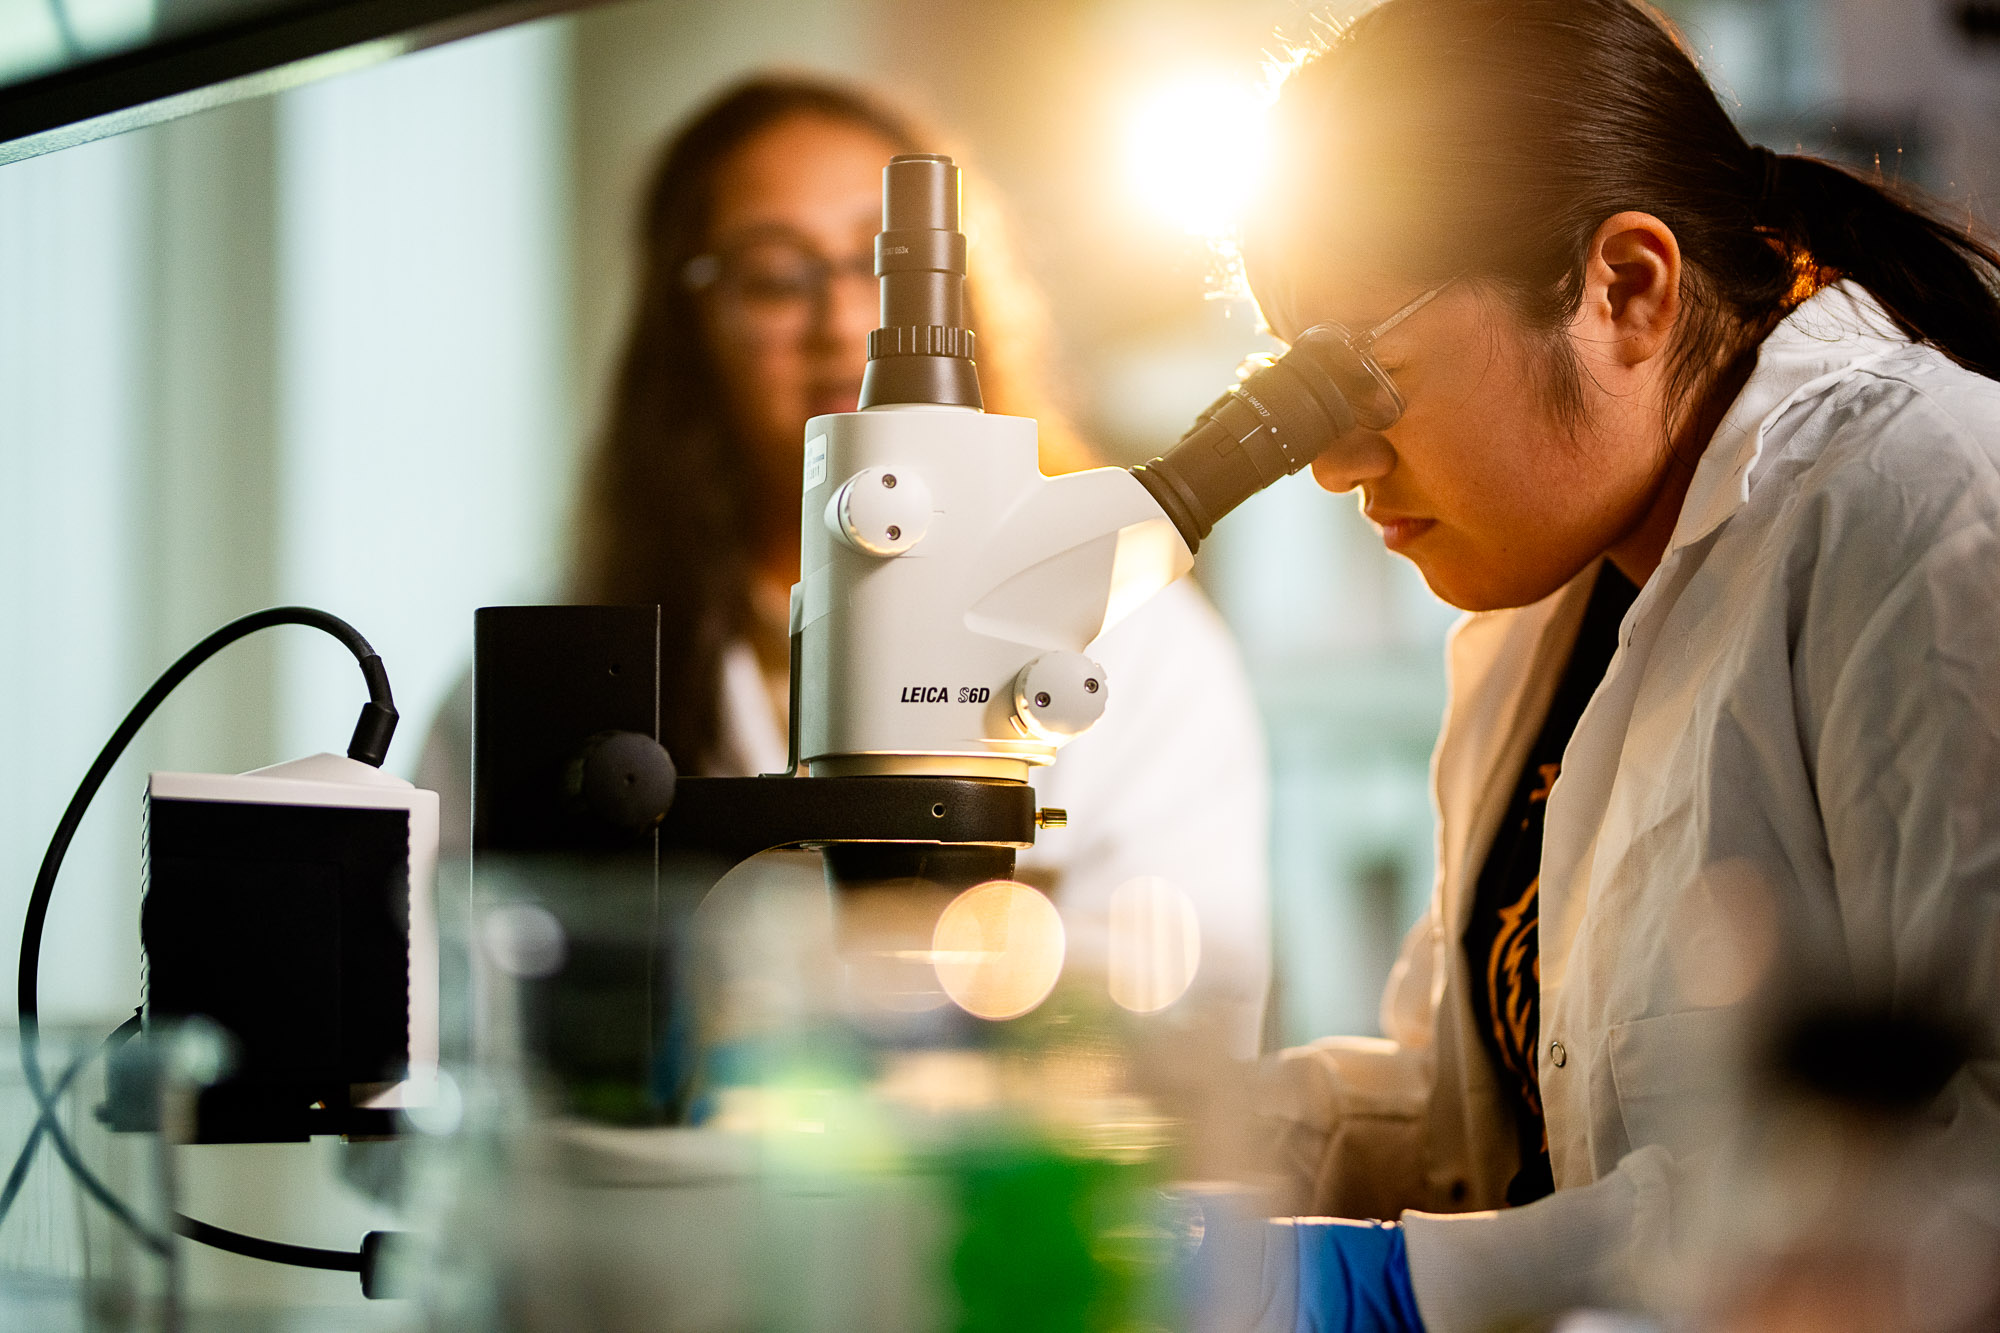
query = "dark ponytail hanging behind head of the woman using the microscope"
xmin=1762 ymin=154 xmax=2000 ymax=378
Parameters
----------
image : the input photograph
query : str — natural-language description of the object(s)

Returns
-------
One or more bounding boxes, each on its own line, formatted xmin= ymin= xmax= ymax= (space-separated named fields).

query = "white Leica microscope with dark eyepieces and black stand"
xmin=474 ymin=154 xmax=1356 ymax=1121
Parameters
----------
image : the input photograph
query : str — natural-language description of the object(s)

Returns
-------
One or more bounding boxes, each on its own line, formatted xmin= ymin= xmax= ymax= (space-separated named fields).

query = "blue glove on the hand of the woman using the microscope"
xmin=1270 ymin=1217 xmax=1424 ymax=1333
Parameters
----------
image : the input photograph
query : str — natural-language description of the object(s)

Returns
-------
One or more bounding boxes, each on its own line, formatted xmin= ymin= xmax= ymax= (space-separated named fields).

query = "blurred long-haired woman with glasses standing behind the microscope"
xmin=420 ymin=76 xmax=1270 ymax=1055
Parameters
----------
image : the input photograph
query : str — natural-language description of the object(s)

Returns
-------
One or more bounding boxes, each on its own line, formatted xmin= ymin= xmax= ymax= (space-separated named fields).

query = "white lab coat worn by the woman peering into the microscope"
xmin=1268 ymin=284 xmax=2000 ymax=1333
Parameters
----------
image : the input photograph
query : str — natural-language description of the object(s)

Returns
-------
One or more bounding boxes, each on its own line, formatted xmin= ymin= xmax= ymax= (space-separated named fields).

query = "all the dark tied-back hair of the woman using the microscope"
xmin=1244 ymin=0 xmax=2000 ymax=410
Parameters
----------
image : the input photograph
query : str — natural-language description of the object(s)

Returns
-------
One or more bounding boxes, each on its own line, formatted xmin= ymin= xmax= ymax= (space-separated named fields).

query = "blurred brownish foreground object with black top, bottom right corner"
xmin=1696 ymin=984 xmax=2000 ymax=1333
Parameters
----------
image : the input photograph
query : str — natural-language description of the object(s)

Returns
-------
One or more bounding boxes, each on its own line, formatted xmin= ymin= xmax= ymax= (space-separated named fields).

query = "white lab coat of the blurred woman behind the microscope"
xmin=418 ymin=582 xmax=1270 ymax=1057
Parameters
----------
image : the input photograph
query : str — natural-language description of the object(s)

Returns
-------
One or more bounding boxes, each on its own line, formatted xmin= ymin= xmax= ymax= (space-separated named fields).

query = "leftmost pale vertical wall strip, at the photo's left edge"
xmin=0 ymin=138 xmax=148 ymax=1017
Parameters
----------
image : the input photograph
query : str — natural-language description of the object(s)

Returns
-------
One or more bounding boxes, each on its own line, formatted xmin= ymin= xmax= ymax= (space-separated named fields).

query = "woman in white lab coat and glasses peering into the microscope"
xmin=1192 ymin=0 xmax=2000 ymax=1331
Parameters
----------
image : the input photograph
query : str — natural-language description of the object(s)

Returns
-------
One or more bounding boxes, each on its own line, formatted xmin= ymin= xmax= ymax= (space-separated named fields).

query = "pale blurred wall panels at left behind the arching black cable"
xmin=0 ymin=24 xmax=576 ymax=1021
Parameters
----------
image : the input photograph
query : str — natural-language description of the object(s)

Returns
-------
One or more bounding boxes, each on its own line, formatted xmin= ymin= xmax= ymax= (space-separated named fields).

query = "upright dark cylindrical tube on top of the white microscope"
xmin=860 ymin=152 xmax=984 ymax=408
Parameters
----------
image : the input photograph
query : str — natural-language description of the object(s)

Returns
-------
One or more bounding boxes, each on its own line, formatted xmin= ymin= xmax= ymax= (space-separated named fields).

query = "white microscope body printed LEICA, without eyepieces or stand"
xmin=792 ymin=404 xmax=1194 ymax=781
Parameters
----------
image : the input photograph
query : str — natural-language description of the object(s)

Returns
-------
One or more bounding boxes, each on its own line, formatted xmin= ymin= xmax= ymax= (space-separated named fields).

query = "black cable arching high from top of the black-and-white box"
xmin=18 ymin=606 xmax=396 ymax=1255
